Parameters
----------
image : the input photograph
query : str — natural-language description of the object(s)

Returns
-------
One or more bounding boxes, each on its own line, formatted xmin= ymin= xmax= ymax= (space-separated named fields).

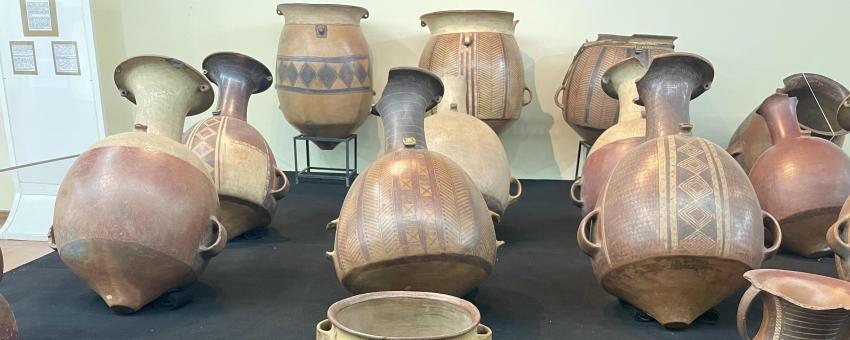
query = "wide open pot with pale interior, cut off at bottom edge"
xmin=316 ymin=291 xmax=493 ymax=340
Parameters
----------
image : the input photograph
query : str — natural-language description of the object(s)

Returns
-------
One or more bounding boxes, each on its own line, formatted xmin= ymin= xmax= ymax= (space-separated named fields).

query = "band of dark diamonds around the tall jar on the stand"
xmin=276 ymin=55 xmax=372 ymax=93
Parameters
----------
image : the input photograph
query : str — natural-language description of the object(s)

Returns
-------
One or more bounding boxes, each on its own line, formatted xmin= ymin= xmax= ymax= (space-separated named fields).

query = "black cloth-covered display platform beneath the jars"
xmin=0 ymin=180 xmax=835 ymax=340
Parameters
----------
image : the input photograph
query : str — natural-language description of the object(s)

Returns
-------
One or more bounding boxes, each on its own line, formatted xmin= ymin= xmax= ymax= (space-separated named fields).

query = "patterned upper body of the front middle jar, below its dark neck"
xmin=336 ymin=151 xmax=496 ymax=272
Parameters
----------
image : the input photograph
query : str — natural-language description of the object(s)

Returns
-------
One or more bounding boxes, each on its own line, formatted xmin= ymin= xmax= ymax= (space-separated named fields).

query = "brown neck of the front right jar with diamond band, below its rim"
xmin=637 ymin=75 xmax=695 ymax=138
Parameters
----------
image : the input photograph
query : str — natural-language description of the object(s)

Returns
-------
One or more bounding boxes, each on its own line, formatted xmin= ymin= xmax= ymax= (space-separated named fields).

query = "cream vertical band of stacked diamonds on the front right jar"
xmin=656 ymin=136 xmax=729 ymax=255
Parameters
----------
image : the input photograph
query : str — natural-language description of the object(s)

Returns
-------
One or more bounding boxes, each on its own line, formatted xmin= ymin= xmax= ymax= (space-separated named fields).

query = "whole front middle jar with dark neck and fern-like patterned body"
xmin=328 ymin=68 xmax=498 ymax=296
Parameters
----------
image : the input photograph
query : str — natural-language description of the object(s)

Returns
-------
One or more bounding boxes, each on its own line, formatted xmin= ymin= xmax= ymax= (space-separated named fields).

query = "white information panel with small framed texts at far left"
xmin=0 ymin=0 xmax=104 ymax=240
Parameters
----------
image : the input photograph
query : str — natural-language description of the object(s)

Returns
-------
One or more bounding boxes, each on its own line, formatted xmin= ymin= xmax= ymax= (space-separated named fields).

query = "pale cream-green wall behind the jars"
xmin=0 ymin=0 xmax=850 ymax=209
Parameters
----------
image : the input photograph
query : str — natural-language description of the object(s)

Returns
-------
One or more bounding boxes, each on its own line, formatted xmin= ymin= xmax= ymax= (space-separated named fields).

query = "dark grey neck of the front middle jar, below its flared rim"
xmin=377 ymin=92 xmax=428 ymax=153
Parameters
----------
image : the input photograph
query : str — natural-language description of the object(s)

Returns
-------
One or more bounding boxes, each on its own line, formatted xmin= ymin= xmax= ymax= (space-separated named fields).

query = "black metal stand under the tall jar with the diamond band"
xmin=292 ymin=134 xmax=357 ymax=187
